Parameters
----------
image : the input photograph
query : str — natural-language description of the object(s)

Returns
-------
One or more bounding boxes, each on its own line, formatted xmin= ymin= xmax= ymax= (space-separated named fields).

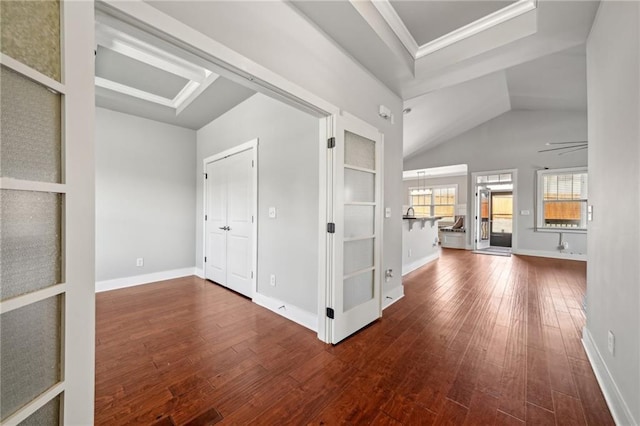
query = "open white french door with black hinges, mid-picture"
xmin=327 ymin=114 xmax=382 ymax=344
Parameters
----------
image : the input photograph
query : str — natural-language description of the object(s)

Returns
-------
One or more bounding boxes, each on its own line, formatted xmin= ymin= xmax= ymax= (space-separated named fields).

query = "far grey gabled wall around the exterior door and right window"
xmin=404 ymin=111 xmax=587 ymax=259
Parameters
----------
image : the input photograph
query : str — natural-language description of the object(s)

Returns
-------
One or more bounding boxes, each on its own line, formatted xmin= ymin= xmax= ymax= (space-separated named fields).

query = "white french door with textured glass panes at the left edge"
xmin=0 ymin=0 xmax=96 ymax=425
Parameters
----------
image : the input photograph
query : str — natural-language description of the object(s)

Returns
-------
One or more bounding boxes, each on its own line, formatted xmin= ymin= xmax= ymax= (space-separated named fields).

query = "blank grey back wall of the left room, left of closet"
xmin=95 ymin=108 xmax=196 ymax=282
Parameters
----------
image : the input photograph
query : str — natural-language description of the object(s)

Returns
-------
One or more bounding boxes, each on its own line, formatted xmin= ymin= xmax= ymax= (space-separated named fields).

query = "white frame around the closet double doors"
xmin=202 ymin=138 xmax=258 ymax=299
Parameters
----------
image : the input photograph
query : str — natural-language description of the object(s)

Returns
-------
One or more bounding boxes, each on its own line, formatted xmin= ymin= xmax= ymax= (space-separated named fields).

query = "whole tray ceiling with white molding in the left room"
xmin=95 ymin=13 xmax=256 ymax=130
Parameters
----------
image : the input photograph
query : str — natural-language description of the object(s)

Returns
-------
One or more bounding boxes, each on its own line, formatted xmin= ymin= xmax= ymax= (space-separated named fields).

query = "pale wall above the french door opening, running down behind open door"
xmin=150 ymin=1 xmax=403 ymax=300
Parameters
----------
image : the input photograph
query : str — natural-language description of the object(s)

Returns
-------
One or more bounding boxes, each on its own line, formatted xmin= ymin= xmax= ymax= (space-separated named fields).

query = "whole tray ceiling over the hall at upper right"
xmin=291 ymin=0 xmax=599 ymax=158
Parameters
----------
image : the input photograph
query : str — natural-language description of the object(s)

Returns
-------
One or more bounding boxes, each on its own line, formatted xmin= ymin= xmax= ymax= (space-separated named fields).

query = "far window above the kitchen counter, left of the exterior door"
xmin=409 ymin=185 xmax=458 ymax=222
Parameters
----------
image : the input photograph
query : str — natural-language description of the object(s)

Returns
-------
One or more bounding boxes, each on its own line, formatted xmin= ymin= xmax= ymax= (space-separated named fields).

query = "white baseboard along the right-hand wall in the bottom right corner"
xmin=582 ymin=327 xmax=638 ymax=426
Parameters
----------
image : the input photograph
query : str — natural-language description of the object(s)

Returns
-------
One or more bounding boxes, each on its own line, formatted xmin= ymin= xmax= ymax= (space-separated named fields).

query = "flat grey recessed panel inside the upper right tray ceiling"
xmin=391 ymin=0 xmax=515 ymax=46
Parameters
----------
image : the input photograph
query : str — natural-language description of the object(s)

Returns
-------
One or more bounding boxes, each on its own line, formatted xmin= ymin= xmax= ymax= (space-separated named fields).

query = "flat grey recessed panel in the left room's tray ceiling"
xmin=96 ymin=46 xmax=189 ymax=99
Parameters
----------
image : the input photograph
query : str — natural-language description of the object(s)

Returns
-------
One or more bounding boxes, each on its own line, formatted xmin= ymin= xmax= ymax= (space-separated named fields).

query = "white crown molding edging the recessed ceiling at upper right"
xmin=372 ymin=0 xmax=536 ymax=59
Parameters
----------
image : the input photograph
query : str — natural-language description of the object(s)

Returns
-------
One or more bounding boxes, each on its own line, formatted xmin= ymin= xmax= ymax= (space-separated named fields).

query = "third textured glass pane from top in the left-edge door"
xmin=0 ymin=189 xmax=62 ymax=300
